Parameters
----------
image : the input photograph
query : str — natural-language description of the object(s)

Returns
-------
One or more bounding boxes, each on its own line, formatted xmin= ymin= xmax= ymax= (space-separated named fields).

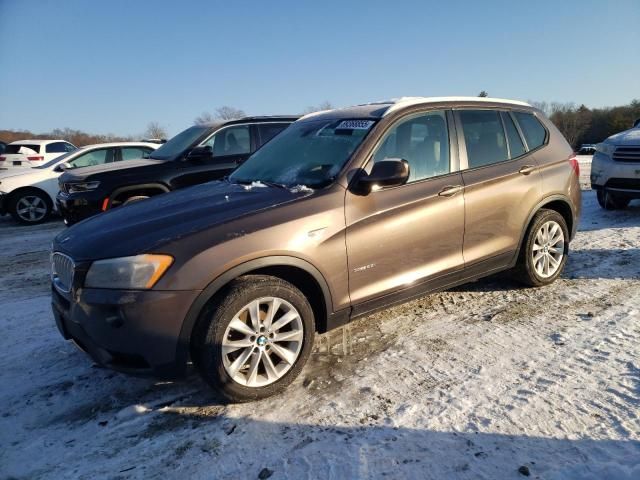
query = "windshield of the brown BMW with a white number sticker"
xmin=229 ymin=119 xmax=375 ymax=188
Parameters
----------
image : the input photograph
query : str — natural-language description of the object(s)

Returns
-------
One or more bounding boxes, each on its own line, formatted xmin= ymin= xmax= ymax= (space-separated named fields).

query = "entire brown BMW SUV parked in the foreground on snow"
xmin=52 ymin=97 xmax=580 ymax=401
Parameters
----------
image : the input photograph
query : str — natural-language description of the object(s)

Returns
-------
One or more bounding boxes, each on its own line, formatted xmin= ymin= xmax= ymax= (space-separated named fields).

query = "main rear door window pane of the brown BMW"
xmin=460 ymin=110 xmax=509 ymax=168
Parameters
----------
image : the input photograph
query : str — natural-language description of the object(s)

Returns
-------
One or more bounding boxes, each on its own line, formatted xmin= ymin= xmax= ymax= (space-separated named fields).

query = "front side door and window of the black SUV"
xmin=172 ymin=124 xmax=255 ymax=188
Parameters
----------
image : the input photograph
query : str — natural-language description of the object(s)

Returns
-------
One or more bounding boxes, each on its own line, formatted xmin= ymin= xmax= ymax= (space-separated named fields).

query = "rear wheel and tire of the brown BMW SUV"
xmin=514 ymin=209 xmax=569 ymax=287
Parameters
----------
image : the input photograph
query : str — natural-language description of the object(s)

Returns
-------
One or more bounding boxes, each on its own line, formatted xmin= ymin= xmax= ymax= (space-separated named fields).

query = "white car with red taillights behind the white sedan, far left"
xmin=0 ymin=140 xmax=77 ymax=170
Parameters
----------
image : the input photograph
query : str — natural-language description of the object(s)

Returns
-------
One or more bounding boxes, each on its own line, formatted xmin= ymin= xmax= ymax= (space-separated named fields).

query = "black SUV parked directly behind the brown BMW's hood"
xmin=56 ymin=116 xmax=297 ymax=225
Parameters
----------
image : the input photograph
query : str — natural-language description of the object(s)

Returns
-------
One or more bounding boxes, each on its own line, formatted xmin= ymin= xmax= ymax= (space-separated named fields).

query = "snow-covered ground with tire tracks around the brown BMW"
xmin=0 ymin=192 xmax=640 ymax=480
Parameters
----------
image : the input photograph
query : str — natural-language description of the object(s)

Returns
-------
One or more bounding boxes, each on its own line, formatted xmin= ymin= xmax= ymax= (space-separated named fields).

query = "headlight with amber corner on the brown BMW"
xmin=85 ymin=255 xmax=173 ymax=290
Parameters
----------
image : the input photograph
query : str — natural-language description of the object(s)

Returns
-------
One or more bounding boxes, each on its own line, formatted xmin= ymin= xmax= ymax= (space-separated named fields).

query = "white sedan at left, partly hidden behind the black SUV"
xmin=0 ymin=142 xmax=160 ymax=224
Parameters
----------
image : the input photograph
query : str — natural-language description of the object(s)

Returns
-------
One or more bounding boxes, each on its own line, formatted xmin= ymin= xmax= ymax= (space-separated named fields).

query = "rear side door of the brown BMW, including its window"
xmin=455 ymin=109 xmax=542 ymax=270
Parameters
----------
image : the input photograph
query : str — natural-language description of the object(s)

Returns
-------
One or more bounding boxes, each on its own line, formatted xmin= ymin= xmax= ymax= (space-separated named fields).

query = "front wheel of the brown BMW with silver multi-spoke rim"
xmin=193 ymin=275 xmax=315 ymax=402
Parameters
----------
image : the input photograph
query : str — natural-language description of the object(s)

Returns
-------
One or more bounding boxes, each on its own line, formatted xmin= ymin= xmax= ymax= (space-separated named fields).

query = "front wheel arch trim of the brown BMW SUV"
xmin=176 ymin=255 xmax=333 ymax=364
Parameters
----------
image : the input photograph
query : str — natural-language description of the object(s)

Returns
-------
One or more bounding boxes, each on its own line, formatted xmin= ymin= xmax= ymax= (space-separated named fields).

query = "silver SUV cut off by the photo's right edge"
xmin=591 ymin=122 xmax=640 ymax=210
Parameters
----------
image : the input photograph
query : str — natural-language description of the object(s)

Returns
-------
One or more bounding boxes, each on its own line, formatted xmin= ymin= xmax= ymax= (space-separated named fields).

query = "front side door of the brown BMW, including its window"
xmin=345 ymin=111 xmax=464 ymax=313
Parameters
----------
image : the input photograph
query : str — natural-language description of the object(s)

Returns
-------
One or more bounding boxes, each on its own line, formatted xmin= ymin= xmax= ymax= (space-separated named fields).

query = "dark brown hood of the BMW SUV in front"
xmin=53 ymin=181 xmax=311 ymax=261
